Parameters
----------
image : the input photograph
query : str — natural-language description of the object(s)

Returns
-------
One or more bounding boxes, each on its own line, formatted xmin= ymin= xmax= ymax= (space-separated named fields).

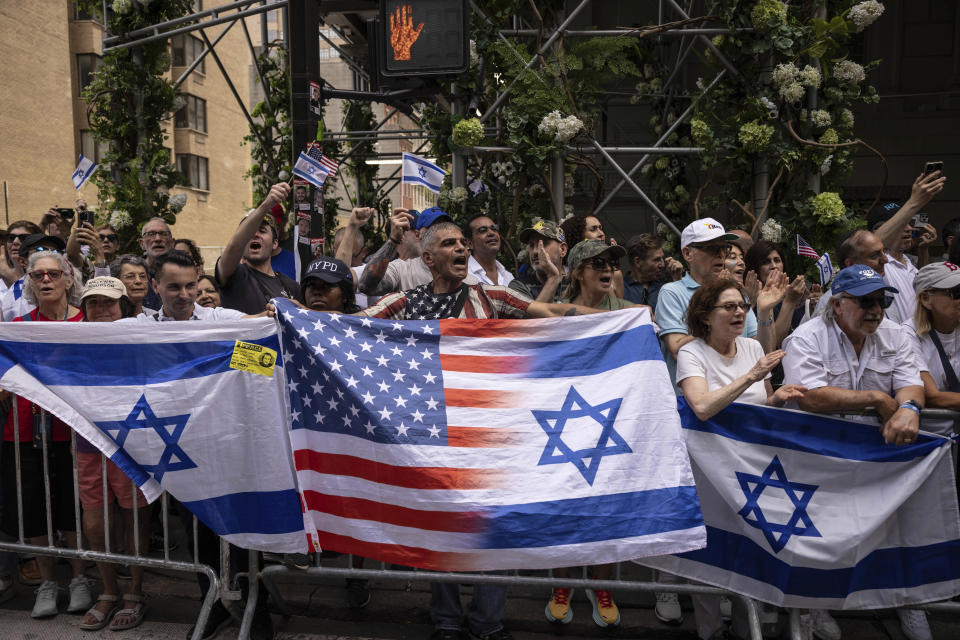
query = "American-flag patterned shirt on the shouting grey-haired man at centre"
xmin=359 ymin=283 xmax=533 ymax=320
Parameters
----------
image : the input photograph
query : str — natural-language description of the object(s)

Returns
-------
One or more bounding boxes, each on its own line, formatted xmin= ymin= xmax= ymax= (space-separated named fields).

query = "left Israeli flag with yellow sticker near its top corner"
xmin=0 ymin=318 xmax=312 ymax=553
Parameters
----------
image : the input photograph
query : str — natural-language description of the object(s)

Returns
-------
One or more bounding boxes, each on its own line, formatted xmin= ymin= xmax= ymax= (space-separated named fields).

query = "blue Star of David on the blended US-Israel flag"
xmin=532 ymin=386 xmax=633 ymax=486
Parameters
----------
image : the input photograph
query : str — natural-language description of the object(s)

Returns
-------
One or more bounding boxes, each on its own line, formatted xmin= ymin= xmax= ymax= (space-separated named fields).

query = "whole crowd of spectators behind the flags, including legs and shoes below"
xmin=0 ymin=172 xmax=948 ymax=640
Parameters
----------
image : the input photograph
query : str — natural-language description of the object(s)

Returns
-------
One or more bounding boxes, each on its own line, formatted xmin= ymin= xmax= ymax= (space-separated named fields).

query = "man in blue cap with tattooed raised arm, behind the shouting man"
xmin=357 ymin=207 xmax=478 ymax=299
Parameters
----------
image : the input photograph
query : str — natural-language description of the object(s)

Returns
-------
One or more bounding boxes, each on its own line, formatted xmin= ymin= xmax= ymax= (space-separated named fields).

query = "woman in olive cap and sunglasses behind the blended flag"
xmin=562 ymin=239 xmax=633 ymax=311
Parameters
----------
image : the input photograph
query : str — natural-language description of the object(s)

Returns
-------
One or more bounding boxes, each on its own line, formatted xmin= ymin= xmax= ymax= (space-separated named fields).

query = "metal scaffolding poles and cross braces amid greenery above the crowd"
xmin=103 ymin=0 xmax=766 ymax=235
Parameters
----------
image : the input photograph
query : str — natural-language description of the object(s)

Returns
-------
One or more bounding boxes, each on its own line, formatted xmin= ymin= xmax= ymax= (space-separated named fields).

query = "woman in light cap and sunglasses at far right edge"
xmin=904 ymin=262 xmax=960 ymax=435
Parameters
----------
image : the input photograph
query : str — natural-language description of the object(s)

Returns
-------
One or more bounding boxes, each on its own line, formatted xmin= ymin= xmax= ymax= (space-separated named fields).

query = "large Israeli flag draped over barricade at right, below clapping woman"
xmin=642 ymin=400 xmax=960 ymax=609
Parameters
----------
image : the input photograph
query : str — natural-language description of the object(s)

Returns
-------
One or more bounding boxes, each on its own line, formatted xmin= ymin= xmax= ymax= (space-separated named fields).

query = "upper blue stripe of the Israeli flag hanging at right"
xmin=677 ymin=398 xmax=949 ymax=462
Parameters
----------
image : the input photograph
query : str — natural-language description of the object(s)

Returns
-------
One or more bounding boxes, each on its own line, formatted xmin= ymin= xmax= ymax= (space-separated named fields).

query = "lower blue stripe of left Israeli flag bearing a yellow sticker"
xmin=177 ymin=489 xmax=303 ymax=536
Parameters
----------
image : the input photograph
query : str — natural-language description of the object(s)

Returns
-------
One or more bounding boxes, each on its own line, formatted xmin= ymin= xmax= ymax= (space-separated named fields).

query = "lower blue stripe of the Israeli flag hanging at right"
xmin=677 ymin=526 xmax=960 ymax=598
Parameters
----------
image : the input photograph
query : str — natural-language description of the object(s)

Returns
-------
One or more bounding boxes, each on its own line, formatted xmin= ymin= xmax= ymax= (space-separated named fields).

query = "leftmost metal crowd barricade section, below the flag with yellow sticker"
xmin=0 ymin=404 xmax=228 ymax=640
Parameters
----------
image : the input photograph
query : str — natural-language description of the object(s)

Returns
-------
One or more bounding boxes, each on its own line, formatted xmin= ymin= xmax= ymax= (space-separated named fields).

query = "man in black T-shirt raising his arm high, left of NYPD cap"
xmin=215 ymin=182 xmax=300 ymax=315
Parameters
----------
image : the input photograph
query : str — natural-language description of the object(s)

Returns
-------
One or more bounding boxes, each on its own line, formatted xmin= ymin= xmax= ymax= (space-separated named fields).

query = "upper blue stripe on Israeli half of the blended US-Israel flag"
xmin=522 ymin=324 xmax=663 ymax=378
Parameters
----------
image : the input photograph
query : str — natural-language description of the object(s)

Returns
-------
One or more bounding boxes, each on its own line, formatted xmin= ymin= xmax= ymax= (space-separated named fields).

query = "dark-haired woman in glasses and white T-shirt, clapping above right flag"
xmin=677 ymin=278 xmax=806 ymax=420
